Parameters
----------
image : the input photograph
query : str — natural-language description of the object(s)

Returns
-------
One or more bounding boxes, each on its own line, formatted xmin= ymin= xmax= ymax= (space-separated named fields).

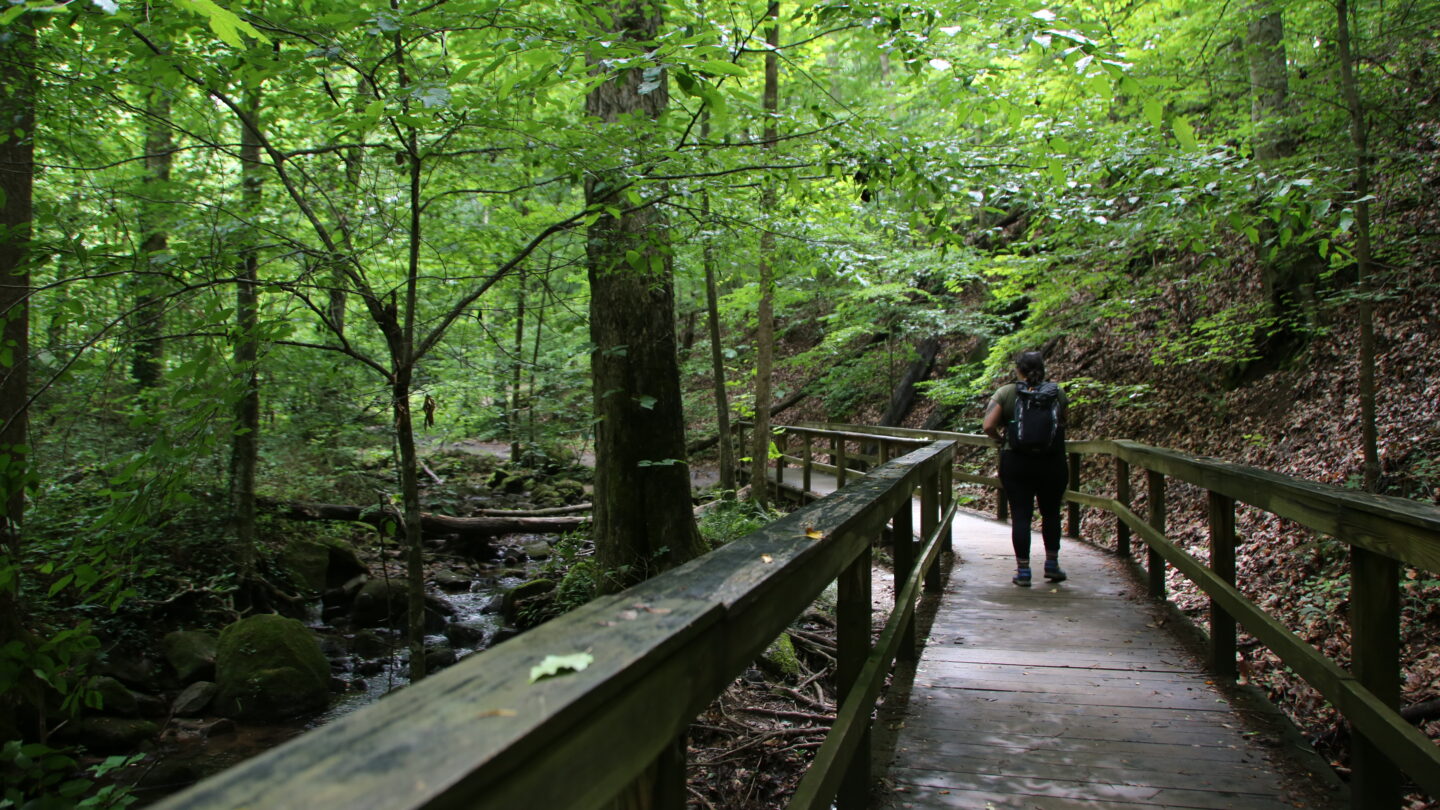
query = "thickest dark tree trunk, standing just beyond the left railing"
xmin=585 ymin=0 xmax=704 ymax=589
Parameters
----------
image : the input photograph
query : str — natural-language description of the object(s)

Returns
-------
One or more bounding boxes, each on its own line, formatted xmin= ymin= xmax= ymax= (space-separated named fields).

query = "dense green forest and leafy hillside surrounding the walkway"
xmin=0 ymin=0 xmax=1440 ymax=804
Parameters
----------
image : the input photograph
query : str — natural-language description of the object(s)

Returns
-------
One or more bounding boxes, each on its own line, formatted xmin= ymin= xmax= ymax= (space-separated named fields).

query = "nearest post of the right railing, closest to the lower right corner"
xmin=1351 ymin=546 xmax=1400 ymax=810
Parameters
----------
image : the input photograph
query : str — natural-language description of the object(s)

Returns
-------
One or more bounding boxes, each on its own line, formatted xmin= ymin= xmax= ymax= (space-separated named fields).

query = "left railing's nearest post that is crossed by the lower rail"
xmin=835 ymin=533 xmax=870 ymax=810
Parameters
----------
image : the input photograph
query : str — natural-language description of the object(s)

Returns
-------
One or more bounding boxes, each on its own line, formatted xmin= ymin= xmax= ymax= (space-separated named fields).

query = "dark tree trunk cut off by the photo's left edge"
xmin=0 ymin=13 xmax=37 ymax=739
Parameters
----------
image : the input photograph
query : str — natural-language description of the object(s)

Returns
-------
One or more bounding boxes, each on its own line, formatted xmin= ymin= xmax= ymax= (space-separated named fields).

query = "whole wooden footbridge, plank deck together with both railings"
xmin=161 ymin=427 xmax=1440 ymax=810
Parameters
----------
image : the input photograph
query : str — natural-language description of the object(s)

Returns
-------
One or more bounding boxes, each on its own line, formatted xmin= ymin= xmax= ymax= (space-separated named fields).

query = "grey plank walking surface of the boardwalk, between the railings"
xmin=771 ymin=464 xmax=1342 ymax=810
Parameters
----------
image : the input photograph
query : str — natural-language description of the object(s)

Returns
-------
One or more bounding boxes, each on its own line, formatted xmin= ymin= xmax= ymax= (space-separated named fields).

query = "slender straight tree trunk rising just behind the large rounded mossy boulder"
xmin=230 ymin=89 xmax=265 ymax=582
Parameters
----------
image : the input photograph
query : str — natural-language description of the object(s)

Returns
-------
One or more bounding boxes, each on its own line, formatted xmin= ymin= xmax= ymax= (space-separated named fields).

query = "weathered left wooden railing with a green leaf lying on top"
xmin=160 ymin=431 xmax=955 ymax=810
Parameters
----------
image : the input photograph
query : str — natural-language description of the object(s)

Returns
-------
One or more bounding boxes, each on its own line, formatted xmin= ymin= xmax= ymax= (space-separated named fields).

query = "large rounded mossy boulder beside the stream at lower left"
xmin=215 ymin=614 xmax=330 ymax=721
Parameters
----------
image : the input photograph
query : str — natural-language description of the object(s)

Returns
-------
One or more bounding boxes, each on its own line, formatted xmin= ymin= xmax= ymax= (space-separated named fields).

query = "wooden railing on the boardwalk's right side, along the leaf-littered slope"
xmin=789 ymin=425 xmax=1440 ymax=810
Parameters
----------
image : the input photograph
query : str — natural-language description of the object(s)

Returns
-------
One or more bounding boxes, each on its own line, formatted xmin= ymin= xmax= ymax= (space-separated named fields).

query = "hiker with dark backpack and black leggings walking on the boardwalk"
xmin=984 ymin=352 xmax=1067 ymax=588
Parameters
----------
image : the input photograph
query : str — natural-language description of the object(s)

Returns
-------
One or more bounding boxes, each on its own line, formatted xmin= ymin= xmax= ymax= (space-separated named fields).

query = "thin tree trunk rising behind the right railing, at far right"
xmin=1335 ymin=0 xmax=1380 ymax=491
